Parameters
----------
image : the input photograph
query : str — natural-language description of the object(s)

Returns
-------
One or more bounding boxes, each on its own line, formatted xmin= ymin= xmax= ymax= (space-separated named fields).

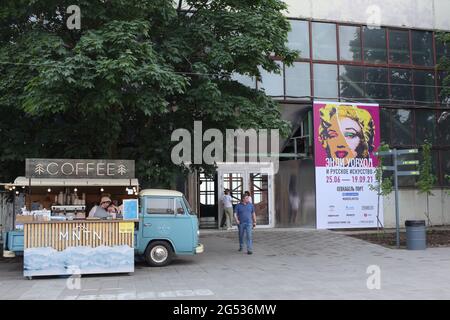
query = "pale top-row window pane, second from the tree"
xmin=312 ymin=22 xmax=337 ymax=60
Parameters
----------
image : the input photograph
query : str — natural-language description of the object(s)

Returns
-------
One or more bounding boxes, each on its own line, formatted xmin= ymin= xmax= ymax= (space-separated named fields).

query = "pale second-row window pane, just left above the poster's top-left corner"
xmin=285 ymin=62 xmax=311 ymax=99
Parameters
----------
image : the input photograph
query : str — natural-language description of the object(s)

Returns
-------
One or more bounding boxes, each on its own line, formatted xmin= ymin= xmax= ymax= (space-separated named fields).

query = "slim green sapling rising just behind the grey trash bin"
xmin=417 ymin=141 xmax=437 ymax=226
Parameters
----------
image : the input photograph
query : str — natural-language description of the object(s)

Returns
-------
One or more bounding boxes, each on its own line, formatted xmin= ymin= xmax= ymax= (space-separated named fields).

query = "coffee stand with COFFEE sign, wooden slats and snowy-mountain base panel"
xmin=5 ymin=159 xmax=139 ymax=277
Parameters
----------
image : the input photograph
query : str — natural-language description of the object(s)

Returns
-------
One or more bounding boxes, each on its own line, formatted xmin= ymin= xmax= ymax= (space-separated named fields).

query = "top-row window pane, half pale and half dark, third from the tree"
xmin=339 ymin=26 xmax=361 ymax=61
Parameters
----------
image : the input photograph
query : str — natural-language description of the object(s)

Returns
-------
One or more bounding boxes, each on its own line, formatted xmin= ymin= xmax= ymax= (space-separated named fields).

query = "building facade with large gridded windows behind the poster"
xmin=191 ymin=0 xmax=450 ymax=228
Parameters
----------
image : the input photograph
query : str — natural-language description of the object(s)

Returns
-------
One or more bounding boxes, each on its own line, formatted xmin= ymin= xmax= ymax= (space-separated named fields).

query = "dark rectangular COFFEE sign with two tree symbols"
xmin=25 ymin=159 xmax=134 ymax=179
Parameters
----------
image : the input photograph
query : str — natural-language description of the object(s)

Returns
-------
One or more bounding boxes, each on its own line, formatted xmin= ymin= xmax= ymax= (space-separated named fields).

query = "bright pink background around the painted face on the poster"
xmin=313 ymin=102 xmax=381 ymax=167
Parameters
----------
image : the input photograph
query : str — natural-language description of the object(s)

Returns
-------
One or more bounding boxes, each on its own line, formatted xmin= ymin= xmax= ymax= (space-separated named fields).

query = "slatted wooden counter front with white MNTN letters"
xmin=24 ymin=220 xmax=135 ymax=251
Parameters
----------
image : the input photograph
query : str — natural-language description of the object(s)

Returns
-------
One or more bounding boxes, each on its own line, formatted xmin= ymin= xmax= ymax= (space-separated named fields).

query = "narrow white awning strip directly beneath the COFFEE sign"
xmin=6 ymin=177 xmax=139 ymax=188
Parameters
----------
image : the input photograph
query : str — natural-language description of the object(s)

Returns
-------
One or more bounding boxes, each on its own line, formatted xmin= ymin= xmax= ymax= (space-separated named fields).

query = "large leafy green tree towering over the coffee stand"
xmin=0 ymin=0 xmax=298 ymax=186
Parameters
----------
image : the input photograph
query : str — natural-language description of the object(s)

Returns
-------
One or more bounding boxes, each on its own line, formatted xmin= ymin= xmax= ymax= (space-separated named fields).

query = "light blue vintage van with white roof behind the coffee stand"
xmin=4 ymin=189 xmax=204 ymax=267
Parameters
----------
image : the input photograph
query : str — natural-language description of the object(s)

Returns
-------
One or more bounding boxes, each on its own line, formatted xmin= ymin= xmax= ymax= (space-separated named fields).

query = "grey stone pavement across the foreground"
xmin=0 ymin=229 xmax=450 ymax=300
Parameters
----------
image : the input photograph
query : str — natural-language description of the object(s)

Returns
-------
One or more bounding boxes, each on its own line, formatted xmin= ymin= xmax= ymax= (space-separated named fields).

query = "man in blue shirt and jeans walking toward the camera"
xmin=234 ymin=196 xmax=256 ymax=254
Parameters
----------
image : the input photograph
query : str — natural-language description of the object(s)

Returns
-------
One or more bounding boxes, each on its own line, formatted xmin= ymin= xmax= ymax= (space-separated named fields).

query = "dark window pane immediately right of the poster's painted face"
xmin=392 ymin=109 xmax=413 ymax=145
